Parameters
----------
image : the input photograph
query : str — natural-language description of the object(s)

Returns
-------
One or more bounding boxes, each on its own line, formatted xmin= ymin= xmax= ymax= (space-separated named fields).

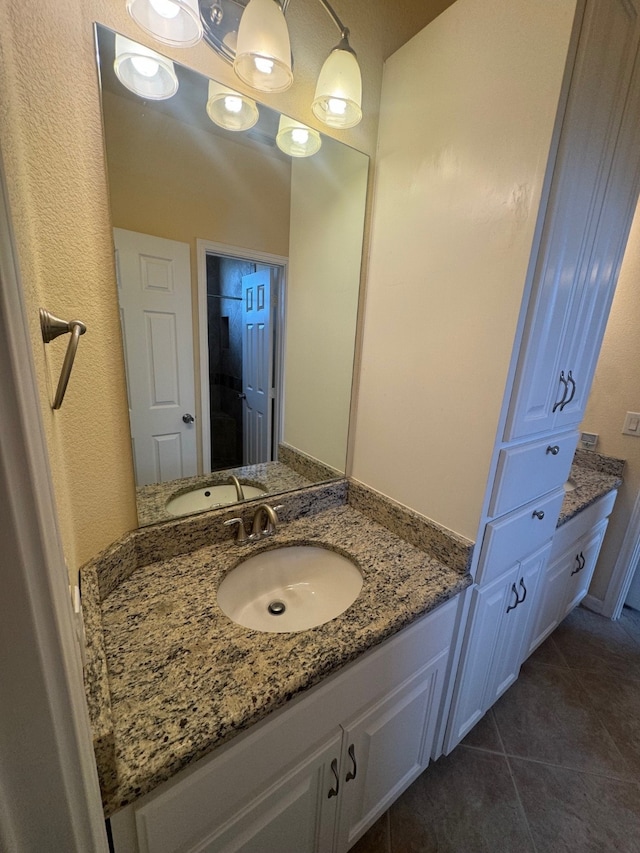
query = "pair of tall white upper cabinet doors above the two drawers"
xmin=505 ymin=0 xmax=638 ymax=440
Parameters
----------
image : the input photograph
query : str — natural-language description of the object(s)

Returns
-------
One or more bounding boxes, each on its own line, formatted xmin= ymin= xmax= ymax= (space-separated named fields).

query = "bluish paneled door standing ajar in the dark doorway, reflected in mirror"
xmin=242 ymin=268 xmax=274 ymax=465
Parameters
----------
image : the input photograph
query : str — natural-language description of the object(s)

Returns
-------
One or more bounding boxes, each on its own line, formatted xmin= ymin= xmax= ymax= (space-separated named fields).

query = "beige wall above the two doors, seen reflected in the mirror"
xmin=104 ymin=92 xmax=291 ymax=256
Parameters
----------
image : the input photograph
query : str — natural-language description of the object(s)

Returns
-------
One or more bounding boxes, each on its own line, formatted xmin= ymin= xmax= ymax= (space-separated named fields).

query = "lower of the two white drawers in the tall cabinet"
xmin=476 ymin=489 xmax=564 ymax=583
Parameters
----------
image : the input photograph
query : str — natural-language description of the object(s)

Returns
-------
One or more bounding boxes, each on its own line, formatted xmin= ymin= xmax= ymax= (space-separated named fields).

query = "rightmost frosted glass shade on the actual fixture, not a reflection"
xmin=311 ymin=47 xmax=362 ymax=128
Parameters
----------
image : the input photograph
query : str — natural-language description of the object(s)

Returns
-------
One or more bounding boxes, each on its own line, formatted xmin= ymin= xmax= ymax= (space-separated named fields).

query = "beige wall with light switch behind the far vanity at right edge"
xmin=581 ymin=201 xmax=640 ymax=599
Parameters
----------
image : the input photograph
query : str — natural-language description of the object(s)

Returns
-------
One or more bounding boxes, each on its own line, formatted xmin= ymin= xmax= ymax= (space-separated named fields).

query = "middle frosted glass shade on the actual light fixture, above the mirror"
xmin=233 ymin=0 xmax=293 ymax=92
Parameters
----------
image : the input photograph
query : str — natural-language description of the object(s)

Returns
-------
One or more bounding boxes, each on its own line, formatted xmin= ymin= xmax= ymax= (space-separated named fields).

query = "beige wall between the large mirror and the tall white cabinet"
xmin=353 ymin=0 xmax=575 ymax=539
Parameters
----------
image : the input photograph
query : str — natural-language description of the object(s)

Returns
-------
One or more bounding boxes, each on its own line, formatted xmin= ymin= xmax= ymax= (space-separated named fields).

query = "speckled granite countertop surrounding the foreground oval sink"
xmin=102 ymin=505 xmax=471 ymax=815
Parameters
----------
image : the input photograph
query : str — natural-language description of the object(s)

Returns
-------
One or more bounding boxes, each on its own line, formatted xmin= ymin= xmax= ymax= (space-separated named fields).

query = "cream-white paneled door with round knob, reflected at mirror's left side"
xmin=113 ymin=228 xmax=197 ymax=486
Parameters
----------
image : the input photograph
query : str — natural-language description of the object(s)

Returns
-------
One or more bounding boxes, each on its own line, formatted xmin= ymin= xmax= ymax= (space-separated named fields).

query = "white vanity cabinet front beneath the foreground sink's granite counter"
xmin=111 ymin=600 xmax=458 ymax=853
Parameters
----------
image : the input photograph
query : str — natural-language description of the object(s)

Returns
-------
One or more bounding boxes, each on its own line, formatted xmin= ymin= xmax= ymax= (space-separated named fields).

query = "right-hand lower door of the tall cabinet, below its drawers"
xmin=484 ymin=542 xmax=551 ymax=709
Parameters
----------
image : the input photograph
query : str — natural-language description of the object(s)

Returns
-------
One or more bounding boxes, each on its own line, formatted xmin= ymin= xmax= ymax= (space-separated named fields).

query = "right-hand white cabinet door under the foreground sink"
xmin=336 ymin=650 xmax=448 ymax=853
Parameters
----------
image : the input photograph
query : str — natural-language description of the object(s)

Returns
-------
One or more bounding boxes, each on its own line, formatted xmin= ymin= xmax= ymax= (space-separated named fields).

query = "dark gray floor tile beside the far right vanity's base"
xmin=553 ymin=607 xmax=640 ymax=679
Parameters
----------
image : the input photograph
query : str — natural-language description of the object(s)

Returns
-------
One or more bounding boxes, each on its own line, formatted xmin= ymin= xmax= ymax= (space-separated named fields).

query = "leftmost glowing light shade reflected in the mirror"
xmin=113 ymin=34 xmax=178 ymax=101
